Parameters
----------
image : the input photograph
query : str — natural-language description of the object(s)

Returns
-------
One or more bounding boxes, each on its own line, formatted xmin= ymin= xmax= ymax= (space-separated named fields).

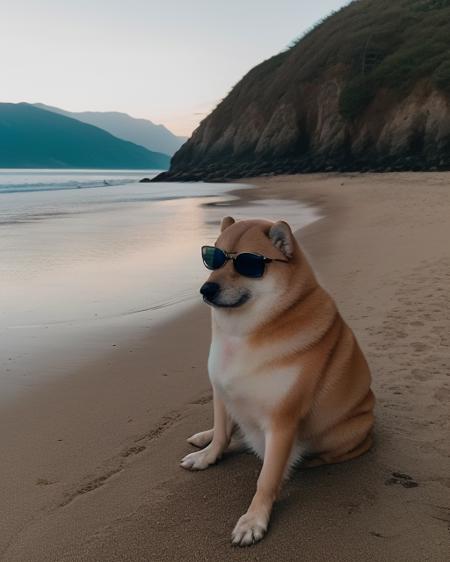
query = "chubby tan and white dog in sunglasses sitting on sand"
xmin=181 ymin=217 xmax=375 ymax=546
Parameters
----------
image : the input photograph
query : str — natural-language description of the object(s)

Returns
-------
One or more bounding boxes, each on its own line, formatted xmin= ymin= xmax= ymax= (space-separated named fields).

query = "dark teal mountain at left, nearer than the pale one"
xmin=0 ymin=103 xmax=170 ymax=169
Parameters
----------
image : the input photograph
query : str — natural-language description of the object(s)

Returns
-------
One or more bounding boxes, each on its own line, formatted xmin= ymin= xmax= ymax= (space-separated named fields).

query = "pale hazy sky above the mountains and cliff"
xmin=0 ymin=0 xmax=348 ymax=135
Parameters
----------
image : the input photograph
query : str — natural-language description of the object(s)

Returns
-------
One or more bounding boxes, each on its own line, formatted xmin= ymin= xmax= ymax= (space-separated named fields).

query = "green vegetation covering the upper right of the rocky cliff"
xmin=329 ymin=0 xmax=450 ymax=118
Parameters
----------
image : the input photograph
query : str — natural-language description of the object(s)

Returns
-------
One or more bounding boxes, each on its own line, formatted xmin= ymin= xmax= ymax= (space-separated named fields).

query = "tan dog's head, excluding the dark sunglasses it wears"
xmin=200 ymin=217 xmax=300 ymax=314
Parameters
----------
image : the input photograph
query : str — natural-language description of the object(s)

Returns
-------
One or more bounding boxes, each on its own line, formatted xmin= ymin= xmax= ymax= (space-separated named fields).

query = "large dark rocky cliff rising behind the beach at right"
xmin=159 ymin=0 xmax=450 ymax=180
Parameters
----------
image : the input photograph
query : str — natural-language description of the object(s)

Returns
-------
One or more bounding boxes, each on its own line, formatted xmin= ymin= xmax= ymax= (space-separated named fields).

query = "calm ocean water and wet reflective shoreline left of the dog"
xmin=0 ymin=170 xmax=318 ymax=396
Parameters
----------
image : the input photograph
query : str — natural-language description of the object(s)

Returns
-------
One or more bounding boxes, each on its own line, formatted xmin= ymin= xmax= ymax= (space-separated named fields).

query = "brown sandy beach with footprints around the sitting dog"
xmin=0 ymin=173 xmax=450 ymax=562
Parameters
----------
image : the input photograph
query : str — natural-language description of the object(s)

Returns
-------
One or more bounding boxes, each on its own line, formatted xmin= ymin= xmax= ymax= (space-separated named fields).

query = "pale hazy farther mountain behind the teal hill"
xmin=34 ymin=103 xmax=187 ymax=156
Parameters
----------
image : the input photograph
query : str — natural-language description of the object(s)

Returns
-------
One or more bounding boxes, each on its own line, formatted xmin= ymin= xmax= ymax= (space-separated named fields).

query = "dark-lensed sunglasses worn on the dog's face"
xmin=202 ymin=246 xmax=287 ymax=279
